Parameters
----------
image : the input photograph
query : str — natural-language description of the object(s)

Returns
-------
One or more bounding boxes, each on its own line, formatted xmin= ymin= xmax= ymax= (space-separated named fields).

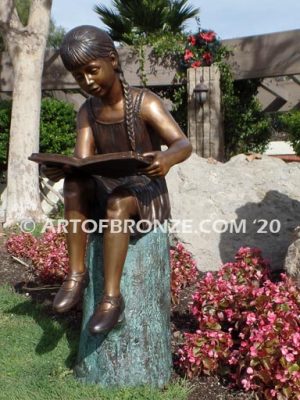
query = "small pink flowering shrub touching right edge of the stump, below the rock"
xmin=170 ymin=243 xmax=198 ymax=304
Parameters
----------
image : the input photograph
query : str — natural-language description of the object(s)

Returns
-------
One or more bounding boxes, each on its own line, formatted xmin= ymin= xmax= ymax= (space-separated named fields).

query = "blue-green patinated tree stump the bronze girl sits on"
xmin=75 ymin=229 xmax=172 ymax=387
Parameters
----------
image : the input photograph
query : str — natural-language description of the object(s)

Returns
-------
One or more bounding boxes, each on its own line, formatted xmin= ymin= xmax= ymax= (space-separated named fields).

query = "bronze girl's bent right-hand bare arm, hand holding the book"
xmin=141 ymin=92 xmax=192 ymax=177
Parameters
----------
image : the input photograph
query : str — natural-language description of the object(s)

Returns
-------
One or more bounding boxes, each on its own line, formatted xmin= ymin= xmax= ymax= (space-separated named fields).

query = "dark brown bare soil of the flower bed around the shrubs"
xmin=0 ymin=232 xmax=251 ymax=400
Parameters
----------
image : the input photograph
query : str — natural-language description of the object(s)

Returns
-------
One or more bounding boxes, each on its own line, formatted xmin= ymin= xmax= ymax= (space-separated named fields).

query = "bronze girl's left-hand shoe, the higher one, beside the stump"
xmin=53 ymin=271 xmax=89 ymax=313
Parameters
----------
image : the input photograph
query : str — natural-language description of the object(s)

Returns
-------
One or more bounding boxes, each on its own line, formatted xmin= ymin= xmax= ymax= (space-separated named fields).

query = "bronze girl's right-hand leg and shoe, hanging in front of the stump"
xmin=90 ymin=192 xmax=138 ymax=333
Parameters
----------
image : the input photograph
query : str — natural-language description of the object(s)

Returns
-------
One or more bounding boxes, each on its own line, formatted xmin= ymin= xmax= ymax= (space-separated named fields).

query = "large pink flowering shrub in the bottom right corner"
xmin=178 ymin=248 xmax=300 ymax=400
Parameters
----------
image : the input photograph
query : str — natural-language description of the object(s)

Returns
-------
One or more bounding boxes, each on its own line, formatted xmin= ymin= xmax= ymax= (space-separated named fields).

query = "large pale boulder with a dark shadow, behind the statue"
xmin=167 ymin=154 xmax=300 ymax=271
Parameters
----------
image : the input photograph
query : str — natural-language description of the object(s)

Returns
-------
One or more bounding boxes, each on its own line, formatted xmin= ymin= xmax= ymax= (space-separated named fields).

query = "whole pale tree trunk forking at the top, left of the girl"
xmin=0 ymin=0 xmax=52 ymax=226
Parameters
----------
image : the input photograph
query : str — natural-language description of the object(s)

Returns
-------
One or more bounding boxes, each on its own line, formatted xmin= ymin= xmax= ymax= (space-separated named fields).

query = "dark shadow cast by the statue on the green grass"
xmin=5 ymin=294 xmax=81 ymax=368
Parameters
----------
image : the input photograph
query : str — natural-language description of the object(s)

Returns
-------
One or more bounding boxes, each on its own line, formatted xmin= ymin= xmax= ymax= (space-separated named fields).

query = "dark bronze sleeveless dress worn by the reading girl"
xmin=87 ymin=90 xmax=170 ymax=227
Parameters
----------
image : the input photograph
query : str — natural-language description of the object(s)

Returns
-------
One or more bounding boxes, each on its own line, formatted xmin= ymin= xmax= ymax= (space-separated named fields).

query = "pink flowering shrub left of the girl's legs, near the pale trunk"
xmin=6 ymin=230 xmax=69 ymax=284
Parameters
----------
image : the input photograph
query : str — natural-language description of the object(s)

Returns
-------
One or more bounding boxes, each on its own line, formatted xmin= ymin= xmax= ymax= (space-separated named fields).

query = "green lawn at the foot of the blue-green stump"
xmin=0 ymin=286 xmax=189 ymax=400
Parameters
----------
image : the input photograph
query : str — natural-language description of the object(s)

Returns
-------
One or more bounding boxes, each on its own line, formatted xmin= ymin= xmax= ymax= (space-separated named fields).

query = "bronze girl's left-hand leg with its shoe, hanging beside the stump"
xmin=53 ymin=176 xmax=95 ymax=312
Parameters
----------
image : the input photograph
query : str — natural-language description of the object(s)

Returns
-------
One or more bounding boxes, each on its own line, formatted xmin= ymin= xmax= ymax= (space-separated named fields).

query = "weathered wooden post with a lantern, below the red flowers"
xmin=187 ymin=66 xmax=224 ymax=161
